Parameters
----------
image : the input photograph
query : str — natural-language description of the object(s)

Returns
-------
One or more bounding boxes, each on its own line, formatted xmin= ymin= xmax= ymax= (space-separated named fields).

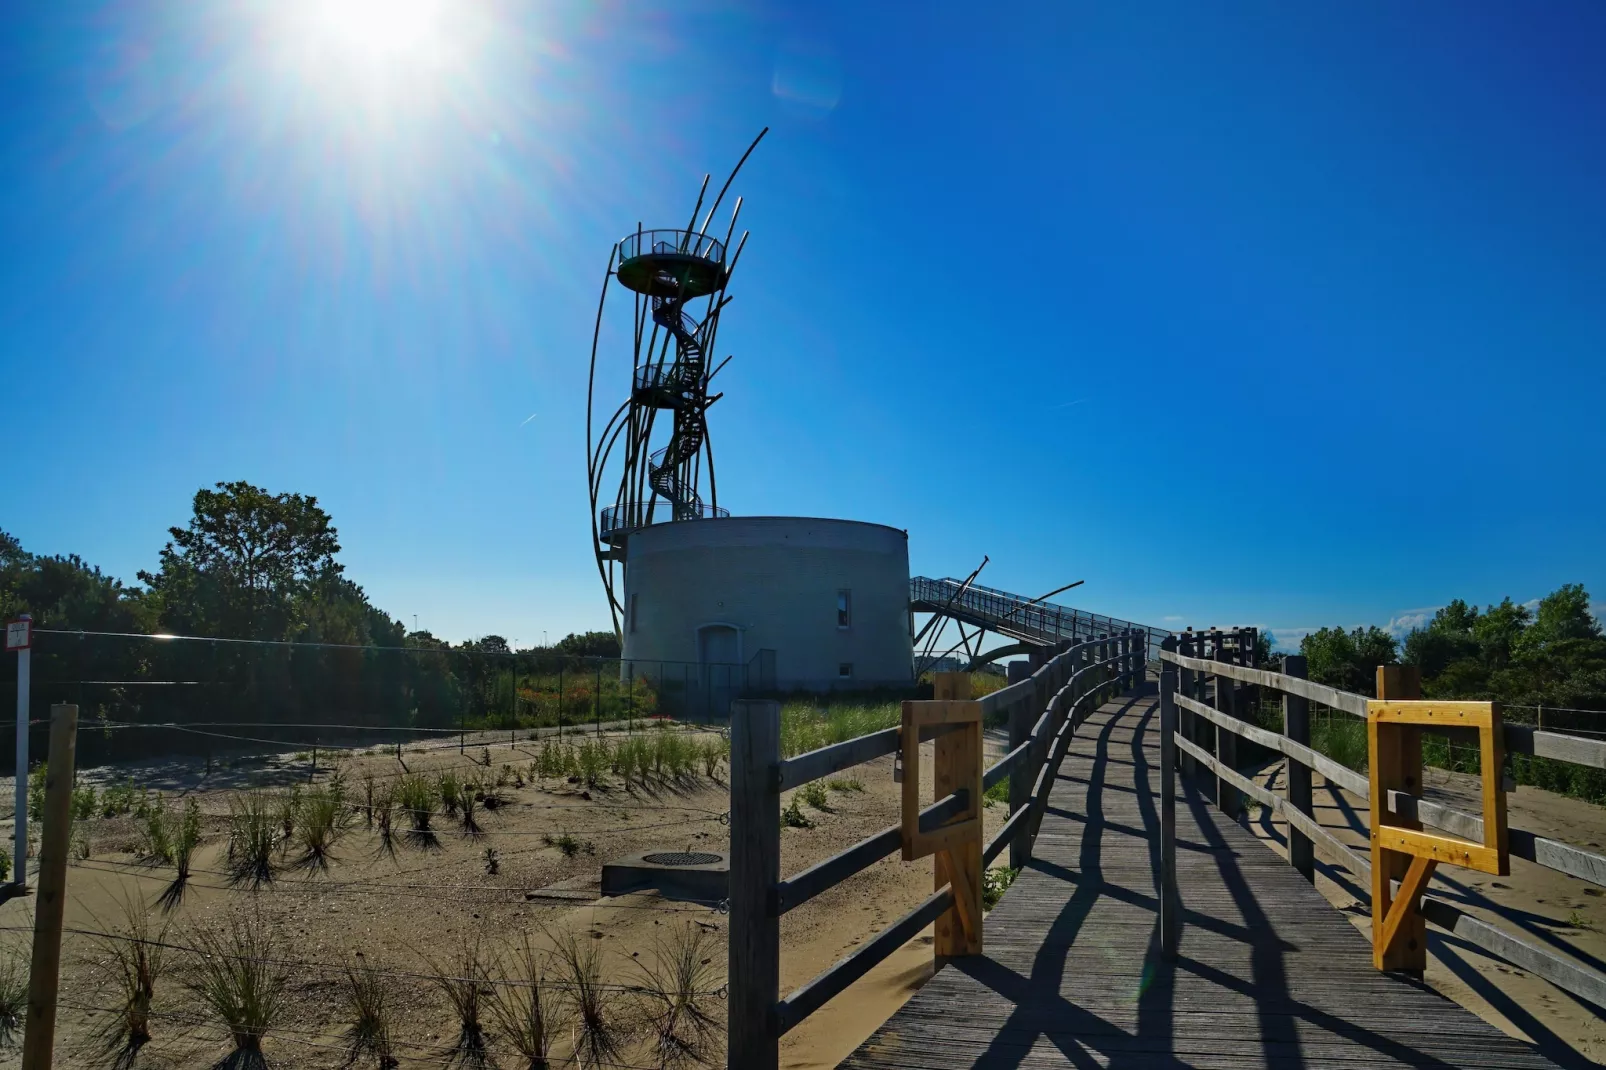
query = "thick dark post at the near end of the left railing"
xmin=726 ymin=699 xmax=781 ymax=1070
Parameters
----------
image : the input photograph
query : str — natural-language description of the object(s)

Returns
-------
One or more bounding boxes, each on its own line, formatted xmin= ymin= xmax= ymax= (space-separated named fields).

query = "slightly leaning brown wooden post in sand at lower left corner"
xmin=22 ymin=705 xmax=79 ymax=1070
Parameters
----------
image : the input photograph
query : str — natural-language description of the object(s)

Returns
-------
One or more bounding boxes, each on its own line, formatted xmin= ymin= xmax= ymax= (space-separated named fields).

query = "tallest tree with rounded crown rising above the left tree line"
xmin=140 ymin=482 xmax=345 ymax=639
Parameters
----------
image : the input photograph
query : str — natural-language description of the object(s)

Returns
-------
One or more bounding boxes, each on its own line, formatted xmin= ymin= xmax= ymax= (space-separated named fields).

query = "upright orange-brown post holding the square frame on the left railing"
xmin=931 ymin=673 xmax=976 ymax=961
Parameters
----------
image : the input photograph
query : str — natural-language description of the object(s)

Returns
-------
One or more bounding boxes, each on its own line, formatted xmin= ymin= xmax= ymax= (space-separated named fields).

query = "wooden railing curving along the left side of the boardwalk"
xmin=728 ymin=631 xmax=1148 ymax=1070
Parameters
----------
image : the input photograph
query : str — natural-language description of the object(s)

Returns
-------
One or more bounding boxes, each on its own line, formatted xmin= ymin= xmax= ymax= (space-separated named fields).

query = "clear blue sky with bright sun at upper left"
xmin=0 ymin=0 xmax=1606 ymax=641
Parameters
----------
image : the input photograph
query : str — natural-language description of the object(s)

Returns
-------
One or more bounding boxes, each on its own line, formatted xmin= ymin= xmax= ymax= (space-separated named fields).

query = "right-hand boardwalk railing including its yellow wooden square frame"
xmin=1160 ymin=631 xmax=1606 ymax=1007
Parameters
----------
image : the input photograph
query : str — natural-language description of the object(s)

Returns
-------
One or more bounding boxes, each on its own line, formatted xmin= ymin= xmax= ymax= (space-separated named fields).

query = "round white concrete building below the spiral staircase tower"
xmin=623 ymin=516 xmax=912 ymax=691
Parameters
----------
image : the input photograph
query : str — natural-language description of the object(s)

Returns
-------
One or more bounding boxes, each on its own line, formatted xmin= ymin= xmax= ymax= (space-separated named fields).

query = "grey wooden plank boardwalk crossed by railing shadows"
xmin=842 ymin=684 xmax=1555 ymax=1070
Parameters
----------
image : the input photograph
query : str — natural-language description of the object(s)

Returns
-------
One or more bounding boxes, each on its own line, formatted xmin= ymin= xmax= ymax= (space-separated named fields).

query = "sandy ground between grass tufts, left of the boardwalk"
xmin=0 ymin=719 xmax=1004 ymax=1070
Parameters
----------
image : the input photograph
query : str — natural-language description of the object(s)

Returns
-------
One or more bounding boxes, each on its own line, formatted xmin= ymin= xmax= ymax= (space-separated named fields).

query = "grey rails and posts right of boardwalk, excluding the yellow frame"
xmin=1160 ymin=631 xmax=1606 ymax=1006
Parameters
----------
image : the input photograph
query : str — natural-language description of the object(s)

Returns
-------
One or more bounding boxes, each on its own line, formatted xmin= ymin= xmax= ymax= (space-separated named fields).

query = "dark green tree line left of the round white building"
xmin=0 ymin=482 xmax=620 ymax=752
